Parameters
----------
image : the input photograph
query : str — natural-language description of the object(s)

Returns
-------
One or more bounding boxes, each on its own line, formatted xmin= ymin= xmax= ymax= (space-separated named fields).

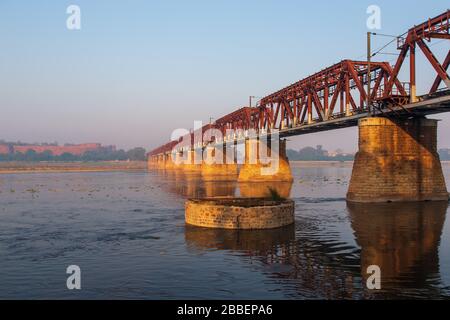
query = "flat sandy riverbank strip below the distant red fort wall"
xmin=0 ymin=161 xmax=147 ymax=174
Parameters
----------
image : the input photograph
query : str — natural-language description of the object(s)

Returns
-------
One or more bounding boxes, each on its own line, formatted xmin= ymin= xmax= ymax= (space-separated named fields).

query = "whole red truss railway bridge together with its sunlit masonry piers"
xmin=148 ymin=11 xmax=450 ymax=202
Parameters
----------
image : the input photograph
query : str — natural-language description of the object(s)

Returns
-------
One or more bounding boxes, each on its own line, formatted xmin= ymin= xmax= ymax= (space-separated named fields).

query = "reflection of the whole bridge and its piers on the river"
xmin=153 ymin=173 xmax=450 ymax=299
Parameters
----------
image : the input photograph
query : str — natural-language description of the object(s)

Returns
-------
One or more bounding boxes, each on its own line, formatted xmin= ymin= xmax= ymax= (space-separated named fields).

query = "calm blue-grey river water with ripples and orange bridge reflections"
xmin=0 ymin=164 xmax=450 ymax=299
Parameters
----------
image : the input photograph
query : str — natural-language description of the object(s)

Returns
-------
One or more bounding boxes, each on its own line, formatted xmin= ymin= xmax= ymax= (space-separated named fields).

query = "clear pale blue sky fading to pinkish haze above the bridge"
xmin=0 ymin=0 xmax=450 ymax=152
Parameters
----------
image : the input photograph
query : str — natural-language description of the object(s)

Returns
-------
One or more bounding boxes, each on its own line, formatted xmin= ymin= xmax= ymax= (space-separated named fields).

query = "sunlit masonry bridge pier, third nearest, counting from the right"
xmin=201 ymin=145 xmax=238 ymax=181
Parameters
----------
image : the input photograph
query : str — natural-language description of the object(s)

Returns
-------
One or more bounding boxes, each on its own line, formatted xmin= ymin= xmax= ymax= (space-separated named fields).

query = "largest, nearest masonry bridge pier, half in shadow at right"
xmin=347 ymin=117 xmax=449 ymax=203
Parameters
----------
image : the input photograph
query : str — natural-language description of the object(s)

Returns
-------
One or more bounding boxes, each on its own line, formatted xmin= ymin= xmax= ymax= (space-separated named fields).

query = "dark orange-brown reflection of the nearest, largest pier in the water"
xmin=348 ymin=201 xmax=448 ymax=297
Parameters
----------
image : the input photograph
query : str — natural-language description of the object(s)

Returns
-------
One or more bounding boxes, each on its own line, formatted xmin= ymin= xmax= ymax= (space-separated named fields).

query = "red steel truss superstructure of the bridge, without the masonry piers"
xmin=149 ymin=10 xmax=450 ymax=156
